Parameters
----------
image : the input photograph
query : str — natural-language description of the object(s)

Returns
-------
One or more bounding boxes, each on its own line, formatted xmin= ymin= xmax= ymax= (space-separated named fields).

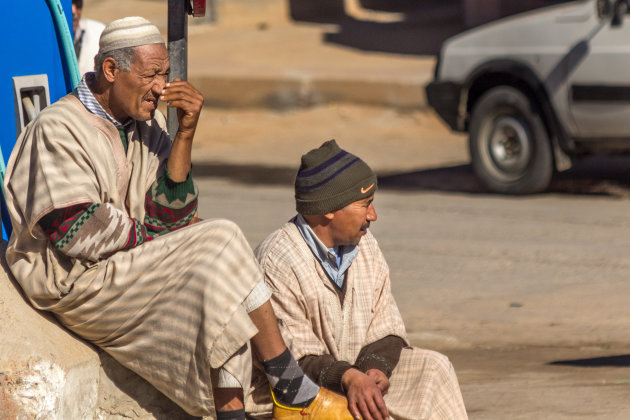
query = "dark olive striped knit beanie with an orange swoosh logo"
xmin=295 ymin=140 xmax=377 ymax=214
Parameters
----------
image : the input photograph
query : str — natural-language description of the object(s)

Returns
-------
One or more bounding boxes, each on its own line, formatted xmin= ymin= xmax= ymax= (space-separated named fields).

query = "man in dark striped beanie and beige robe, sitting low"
xmin=247 ymin=140 xmax=467 ymax=420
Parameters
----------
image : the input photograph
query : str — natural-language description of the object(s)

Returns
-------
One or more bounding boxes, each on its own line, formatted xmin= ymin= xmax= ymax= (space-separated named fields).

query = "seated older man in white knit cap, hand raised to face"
xmin=5 ymin=17 xmax=350 ymax=420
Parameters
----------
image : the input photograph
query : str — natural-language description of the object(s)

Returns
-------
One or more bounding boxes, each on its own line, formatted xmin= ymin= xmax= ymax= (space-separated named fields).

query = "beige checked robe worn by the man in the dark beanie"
xmin=248 ymin=223 xmax=467 ymax=419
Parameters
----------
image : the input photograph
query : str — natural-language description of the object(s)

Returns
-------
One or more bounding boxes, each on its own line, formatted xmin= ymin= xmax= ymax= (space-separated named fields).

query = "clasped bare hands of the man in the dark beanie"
xmin=341 ymin=369 xmax=389 ymax=420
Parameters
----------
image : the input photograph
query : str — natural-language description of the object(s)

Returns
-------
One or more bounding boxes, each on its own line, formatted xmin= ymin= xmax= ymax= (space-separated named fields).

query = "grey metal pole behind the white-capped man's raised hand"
xmin=166 ymin=0 xmax=190 ymax=140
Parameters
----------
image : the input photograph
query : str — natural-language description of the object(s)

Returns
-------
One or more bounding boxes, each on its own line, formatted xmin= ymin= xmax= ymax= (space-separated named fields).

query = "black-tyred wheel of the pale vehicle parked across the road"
xmin=469 ymin=86 xmax=553 ymax=194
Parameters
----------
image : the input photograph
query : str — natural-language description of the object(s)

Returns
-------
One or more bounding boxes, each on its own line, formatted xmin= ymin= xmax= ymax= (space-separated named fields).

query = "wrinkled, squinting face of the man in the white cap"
xmin=109 ymin=44 xmax=170 ymax=122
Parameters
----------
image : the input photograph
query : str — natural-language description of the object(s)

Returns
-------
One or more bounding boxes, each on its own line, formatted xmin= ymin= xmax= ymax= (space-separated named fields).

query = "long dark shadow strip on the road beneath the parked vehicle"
xmin=193 ymin=156 xmax=630 ymax=198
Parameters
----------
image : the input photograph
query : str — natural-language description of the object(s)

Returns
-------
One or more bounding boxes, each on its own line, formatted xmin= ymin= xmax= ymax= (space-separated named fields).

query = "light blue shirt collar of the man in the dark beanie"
xmin=291 ymin=214 xmax=359 ymax=289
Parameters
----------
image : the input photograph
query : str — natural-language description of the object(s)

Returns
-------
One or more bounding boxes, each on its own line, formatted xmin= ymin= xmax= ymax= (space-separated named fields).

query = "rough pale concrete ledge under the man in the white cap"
xmin=0 ymin=241 xmax=194 ymax=420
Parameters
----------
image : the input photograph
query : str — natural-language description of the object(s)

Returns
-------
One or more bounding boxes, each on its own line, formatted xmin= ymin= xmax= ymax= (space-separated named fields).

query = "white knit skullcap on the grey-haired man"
xmin=98 ymin=16 xmax=164 ymax=53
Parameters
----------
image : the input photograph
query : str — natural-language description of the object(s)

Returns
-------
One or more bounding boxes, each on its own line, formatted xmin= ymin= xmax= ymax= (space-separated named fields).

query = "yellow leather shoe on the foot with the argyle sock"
xmin=271 ymin=388 xmax=354 ymax=420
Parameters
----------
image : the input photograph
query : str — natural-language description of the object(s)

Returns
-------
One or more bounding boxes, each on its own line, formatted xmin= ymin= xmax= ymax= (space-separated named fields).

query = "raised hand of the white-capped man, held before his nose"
xmin=160 ymin=79 xmax=203 ymax=134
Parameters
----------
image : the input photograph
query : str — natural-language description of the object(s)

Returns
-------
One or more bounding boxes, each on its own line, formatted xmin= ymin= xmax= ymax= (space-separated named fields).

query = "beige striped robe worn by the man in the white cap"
xmin=5 ymin=95 xmax=262 ymax=415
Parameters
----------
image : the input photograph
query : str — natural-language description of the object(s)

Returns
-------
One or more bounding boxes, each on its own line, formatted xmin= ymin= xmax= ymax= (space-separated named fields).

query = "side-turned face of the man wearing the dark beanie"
xmin=330 ymin=195 xmax=377 ymax=246
